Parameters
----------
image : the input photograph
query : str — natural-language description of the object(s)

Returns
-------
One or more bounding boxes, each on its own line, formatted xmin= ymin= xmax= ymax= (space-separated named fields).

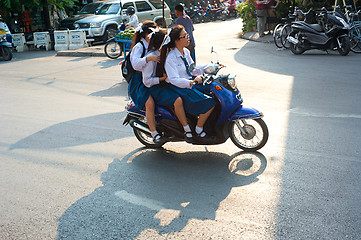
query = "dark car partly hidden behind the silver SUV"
xmin=59 ymin=0 xmax=111 ymax=30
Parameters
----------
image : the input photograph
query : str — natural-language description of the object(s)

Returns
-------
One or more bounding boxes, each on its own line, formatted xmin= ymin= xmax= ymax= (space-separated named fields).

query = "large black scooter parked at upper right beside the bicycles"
xmin=287 ymin=10 xmax=350 ymax=56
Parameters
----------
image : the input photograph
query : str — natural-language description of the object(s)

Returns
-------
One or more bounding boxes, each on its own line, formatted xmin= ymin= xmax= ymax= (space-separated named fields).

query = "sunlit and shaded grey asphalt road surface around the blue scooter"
xmin=0 ymin=20 xmax=361 ymax=240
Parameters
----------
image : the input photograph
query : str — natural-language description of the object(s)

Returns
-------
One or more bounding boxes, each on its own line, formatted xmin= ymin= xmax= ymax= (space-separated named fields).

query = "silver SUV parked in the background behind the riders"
xmin=74 ymin=0 xmax=172 ymax=41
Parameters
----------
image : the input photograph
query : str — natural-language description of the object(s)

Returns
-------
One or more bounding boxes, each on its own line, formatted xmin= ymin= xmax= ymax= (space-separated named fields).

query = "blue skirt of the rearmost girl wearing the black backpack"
xmin=128 ymin=72 xmax=150 ymax=109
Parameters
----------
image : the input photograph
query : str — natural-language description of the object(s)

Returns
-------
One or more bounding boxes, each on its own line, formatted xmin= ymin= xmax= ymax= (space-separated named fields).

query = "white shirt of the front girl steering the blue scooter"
xmin=164 ymin=48 xmax=202 ymax=88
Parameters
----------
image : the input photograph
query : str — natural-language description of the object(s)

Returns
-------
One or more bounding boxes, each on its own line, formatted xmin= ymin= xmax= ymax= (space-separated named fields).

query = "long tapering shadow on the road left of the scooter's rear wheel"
xmin=10 ymin=112 xmax=127 ymax=150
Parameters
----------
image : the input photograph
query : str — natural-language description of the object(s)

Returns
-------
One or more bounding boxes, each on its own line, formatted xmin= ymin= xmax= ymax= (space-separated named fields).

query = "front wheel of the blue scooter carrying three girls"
xmin=229 ymin=118 xmax=268 ymax=152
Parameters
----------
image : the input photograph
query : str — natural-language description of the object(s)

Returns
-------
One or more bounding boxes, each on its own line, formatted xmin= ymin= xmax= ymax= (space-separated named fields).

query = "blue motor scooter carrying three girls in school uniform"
xmin=123 ymin=48 xmax=269 ymax=151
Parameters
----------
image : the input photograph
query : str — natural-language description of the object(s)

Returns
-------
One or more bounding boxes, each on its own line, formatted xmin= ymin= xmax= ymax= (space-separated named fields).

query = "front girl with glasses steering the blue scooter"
xmin=161 ymin=25 xmax=215 ymax=142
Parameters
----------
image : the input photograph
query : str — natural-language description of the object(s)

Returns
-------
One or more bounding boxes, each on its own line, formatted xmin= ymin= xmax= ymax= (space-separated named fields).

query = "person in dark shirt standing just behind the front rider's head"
xmin=174 ymin=4 xmax=196 ymax=64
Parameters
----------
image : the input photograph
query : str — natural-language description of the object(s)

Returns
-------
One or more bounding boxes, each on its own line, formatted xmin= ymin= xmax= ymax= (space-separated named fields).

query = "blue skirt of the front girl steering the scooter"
xmin=169 ymin=85 xmax=216 ymax=116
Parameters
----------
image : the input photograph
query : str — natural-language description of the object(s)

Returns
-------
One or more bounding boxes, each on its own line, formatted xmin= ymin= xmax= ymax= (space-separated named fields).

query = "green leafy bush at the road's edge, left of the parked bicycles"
xmin=237 ymin=0 xmax=257 ymax=33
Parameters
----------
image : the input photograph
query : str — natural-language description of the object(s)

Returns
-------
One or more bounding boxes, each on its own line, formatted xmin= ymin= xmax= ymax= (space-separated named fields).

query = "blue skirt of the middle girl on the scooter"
xmin=149 ymin=84 xmax=180 ymax=107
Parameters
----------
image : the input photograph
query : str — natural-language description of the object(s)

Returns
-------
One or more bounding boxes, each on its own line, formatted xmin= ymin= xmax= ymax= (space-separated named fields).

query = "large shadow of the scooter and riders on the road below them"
xmin=58 ymin=148 xmax=267 ymax=239
